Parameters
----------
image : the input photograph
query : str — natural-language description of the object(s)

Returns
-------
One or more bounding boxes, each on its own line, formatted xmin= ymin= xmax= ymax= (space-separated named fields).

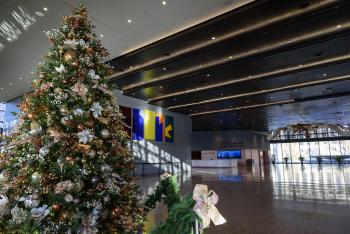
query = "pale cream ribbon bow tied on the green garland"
xmin=192 ymin=184 xmax=226 ymax=229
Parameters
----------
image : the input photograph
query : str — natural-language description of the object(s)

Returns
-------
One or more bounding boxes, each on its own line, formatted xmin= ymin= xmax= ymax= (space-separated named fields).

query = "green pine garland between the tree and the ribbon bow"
xmin=145 ymin=176 xmax=199 ymax=234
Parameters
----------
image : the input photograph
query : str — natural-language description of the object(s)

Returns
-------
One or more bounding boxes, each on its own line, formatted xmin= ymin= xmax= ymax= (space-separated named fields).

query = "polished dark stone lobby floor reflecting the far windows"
xmin=140 ymin=164 xmax=350 ymax=234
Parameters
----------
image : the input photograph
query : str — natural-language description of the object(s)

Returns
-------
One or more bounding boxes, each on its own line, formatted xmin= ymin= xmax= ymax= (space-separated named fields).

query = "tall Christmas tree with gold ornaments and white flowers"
xmin=0 ymin=7 xmax=145 ymax=233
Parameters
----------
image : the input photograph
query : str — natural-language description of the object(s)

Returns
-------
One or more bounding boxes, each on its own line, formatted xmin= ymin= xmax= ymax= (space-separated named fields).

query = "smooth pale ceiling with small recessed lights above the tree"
xmin=0 ymin=0 xmax=252 ymax=102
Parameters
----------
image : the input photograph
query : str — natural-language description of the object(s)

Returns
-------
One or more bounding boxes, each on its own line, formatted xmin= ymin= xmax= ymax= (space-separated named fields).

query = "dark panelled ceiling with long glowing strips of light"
xmin=111 ymin=1 xmax=350 ymax=131
